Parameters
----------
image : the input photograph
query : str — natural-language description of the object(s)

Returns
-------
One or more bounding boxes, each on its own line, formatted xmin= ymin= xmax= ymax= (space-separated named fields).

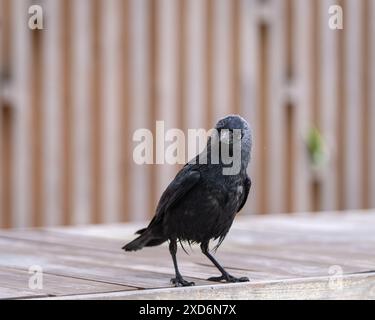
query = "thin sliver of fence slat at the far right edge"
xmin=367 ymin=1 xmax=375 ymax=208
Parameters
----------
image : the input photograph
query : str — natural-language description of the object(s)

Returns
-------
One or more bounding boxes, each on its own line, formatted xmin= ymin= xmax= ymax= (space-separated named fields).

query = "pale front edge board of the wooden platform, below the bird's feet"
xmin=39 ymin=273 xmax=375 ymax=300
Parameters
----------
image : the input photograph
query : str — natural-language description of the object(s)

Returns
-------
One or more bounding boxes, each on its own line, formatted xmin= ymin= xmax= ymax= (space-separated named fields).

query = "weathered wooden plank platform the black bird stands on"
xmin=0 ymin=211 xmax=375 ymax=299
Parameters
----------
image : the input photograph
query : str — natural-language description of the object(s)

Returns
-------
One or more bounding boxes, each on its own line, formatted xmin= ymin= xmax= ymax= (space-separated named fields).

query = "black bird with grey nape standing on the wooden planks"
xmin=123 ymin=115 xmax=252 ymax=286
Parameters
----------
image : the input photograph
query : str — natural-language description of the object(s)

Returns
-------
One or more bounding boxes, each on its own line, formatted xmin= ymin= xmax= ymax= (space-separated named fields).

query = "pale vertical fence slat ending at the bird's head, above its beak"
xmin=212 ymin=0 xmax=233 ymax=123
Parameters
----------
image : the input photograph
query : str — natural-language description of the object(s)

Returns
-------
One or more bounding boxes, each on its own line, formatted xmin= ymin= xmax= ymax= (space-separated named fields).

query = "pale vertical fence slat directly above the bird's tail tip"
xmin=129 ymin=0 xmax=152 ymax=221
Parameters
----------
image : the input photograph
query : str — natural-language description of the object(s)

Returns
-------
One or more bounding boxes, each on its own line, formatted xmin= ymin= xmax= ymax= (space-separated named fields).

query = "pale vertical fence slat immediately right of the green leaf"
xmin=319 ymin=0 xmax=342 ymax=211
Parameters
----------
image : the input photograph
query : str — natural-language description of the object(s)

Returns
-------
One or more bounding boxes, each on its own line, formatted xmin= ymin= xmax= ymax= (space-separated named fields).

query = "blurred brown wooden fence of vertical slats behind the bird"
xmin=0 ymin=0 xmax=375 ymax=227
